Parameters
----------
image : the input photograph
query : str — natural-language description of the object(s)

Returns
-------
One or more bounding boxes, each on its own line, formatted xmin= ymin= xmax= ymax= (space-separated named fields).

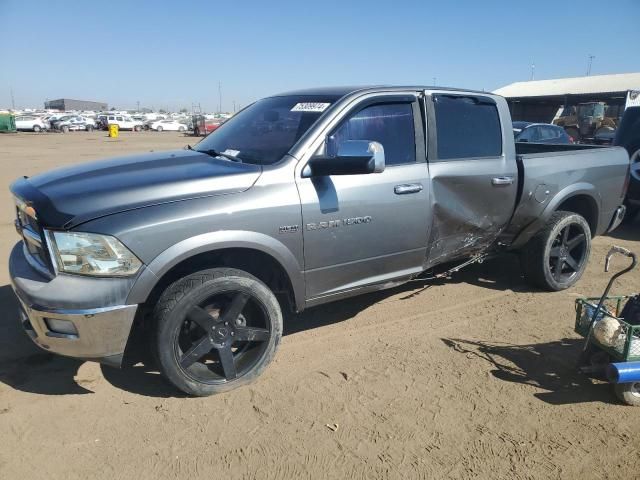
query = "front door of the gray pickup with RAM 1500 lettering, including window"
xmin=296 ymin=95 xmax=429 ymax=299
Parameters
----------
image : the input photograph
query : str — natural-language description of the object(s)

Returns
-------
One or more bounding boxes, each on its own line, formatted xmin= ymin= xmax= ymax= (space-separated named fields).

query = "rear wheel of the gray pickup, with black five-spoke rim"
xmin=521 ymin=212 xmax=591 ymax=291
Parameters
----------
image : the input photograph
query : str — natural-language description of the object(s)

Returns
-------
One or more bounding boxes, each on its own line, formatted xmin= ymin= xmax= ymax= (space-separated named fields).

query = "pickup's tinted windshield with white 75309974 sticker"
xmin=195 ymin=95 xmax=339 ymax=165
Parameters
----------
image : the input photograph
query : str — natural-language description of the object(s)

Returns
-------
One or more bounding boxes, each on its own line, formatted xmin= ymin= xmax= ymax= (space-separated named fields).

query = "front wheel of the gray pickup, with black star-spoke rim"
xmin=154 ymin=268 xmax=282 ymax=396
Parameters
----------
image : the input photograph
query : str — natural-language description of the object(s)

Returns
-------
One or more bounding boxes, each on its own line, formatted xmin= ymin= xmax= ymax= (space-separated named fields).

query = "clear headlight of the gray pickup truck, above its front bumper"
xmin=47 ymin=231 xmax=142 ymax=277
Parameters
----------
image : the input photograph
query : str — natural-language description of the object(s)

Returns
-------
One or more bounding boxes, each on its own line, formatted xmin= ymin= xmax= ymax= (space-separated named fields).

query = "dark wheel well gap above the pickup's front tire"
xmin=145 ymin=248 xmax=296 ymax=311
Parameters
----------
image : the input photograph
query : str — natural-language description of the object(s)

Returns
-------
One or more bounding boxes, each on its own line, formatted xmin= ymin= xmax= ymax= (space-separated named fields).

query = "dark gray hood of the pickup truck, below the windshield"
xmin=11 ymin=150 xmax=262 ymax=229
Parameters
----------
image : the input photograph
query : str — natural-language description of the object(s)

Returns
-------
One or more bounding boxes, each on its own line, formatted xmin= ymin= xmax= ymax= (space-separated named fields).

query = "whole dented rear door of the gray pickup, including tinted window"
xmin=426 ymin=92 xmax=518 ymax=266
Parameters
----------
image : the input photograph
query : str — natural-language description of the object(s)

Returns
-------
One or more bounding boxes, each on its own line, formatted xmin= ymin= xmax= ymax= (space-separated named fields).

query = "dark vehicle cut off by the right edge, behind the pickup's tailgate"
xmin=613 ymin=107 xmax=640 ymax=221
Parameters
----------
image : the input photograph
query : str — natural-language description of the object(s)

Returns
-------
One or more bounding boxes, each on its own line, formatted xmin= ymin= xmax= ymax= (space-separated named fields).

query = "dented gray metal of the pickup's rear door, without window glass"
xmin=425 ymin=92 xmax=518 ymax=268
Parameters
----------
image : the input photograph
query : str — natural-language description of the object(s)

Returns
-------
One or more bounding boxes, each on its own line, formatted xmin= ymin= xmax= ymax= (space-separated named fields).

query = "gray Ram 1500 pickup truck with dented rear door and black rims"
xmin=10 ymin=87 xmax=629 ymax=395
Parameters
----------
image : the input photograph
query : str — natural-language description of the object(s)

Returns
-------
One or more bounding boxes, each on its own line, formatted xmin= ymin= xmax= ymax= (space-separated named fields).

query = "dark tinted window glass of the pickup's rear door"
xmin=433 ymin=95 xmax=502 ymax=160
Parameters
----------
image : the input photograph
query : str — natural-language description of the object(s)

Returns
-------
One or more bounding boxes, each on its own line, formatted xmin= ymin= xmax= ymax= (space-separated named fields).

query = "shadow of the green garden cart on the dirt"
xmin=442 ymin=338 xmax=618 ymax=405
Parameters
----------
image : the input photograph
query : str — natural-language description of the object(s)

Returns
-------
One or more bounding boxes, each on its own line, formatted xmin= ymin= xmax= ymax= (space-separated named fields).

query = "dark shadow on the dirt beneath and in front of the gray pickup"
xmin=0 ymin=255 xmax=540 ymax=398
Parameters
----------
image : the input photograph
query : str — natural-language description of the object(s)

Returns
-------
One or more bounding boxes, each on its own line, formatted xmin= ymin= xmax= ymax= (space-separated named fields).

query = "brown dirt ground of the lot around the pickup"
xmin=0 ymin=132 xmax=640 ymax=480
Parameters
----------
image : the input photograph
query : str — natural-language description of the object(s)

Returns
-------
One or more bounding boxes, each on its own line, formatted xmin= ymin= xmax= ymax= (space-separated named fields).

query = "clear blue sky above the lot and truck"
xmin=0 ymin=0 xmax=640 ymax=111
